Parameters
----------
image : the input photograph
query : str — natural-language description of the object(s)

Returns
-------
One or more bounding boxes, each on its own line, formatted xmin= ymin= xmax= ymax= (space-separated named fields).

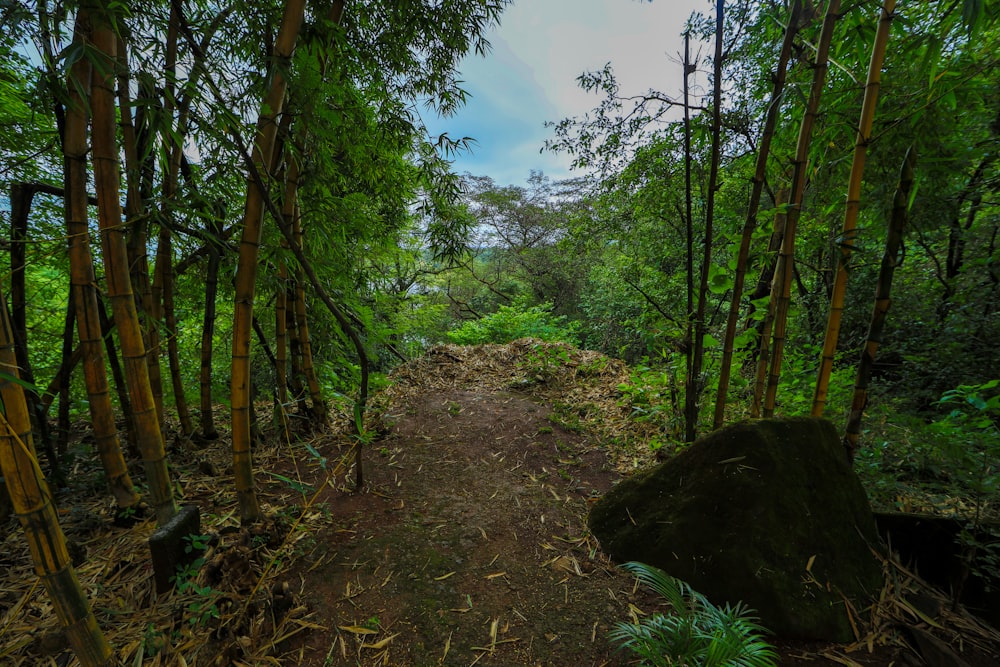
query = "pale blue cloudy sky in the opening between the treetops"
xmin=424 ymin=0 xmax=714 ymax=185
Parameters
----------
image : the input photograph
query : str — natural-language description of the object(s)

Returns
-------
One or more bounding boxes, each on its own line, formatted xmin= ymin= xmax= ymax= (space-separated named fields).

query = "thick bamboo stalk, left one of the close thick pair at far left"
xmin=63 ymin=14 xmax=138 ymax=508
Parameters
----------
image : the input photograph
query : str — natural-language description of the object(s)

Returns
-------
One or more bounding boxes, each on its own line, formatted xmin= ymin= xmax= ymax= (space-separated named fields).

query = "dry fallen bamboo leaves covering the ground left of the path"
xmin=0 ymin=406 xmax=356 ymax=667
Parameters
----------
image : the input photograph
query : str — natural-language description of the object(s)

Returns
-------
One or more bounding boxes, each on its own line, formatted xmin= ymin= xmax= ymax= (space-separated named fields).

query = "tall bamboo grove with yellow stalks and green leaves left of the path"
xmin=0 ymin=0 xmax=504 ymax=665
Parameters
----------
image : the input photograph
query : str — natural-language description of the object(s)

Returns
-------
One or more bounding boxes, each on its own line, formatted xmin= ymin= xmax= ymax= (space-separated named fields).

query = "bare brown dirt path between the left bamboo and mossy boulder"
xmin=290 ymin=390 xmax=635 ymax=665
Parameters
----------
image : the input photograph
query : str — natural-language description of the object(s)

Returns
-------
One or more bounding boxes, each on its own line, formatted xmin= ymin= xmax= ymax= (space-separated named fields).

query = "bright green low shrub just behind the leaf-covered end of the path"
xmin=447 ymin=301 xmax=579 ymax=345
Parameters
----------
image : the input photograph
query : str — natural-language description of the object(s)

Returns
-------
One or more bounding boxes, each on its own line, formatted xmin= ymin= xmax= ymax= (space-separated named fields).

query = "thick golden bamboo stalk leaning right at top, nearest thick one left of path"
xmin=230 ymin=0 xmax=305 ymax=524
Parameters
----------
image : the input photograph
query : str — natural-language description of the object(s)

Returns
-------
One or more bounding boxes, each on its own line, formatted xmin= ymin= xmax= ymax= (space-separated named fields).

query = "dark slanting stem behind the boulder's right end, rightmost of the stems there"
xmin=844 ymin=147 xmax=916 ymax=461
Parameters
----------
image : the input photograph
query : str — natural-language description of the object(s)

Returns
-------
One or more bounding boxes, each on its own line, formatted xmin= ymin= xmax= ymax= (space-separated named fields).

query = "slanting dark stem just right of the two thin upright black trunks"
xmin=713 ymin=0 xmax=802 ymax=428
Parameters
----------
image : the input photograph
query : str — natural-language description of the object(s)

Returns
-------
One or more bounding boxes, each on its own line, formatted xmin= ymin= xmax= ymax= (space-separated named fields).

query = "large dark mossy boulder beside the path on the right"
xmin=589 ymin=418 xmax=882 ymax=641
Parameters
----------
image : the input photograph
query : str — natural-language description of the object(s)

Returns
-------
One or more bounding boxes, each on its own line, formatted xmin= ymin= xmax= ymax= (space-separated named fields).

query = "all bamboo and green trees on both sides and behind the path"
xmin=0 ymin=0 xmax=1000 ymax=666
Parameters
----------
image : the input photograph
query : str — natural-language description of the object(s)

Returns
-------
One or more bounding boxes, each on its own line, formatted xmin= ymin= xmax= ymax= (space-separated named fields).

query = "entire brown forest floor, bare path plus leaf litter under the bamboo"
xmin=0 ymin=341 xmax=998 ymax=667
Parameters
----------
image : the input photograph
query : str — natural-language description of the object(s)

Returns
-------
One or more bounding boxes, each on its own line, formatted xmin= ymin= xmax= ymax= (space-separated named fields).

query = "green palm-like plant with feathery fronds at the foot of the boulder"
xmin=611 ymin=562 xmax=777 ymax=667
